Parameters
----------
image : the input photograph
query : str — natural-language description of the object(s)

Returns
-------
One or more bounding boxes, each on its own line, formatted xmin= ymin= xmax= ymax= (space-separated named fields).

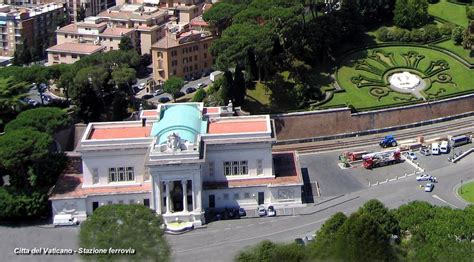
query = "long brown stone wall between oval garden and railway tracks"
xmin=272 ymin=94 xmax=474 ymax=142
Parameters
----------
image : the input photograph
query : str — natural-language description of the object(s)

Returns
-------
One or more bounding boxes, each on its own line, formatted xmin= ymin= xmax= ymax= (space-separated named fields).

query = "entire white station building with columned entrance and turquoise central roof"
xmin=50 ymin=103 xmax=303 ymax=225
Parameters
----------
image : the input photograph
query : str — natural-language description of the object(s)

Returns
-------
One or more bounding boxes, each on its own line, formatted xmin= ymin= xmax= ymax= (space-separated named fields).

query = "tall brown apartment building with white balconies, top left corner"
xmin=0 ymin=3 xmax=64 ymax=56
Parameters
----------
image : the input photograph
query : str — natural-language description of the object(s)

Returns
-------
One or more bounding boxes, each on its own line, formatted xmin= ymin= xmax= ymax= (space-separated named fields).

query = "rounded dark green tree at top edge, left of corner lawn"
xmin=393 ymin=0 xmax=430 ymax=29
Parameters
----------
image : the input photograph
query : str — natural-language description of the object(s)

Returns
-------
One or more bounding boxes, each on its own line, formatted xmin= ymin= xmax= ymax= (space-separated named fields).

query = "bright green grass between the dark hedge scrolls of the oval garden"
xmin=323 ymin=46 xmax=474 ymax=109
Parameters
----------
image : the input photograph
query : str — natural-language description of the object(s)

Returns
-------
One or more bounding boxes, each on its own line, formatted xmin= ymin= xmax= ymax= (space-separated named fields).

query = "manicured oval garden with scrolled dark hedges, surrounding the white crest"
xmin=322 ymin=45 xmax=474 ymax=109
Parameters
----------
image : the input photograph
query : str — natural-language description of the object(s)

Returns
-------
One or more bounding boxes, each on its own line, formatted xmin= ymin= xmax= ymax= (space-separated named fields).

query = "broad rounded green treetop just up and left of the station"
xmin=5 ymin=107 xmax=71 ymax=135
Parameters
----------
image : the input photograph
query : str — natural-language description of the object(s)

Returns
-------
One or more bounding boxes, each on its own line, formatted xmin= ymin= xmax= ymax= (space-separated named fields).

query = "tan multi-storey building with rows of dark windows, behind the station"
xmin=152 ymin=29 xmax=214 ymax=83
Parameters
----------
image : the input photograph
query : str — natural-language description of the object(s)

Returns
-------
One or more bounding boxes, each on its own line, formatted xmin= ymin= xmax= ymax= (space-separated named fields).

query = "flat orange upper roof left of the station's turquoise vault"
xmin=87 ymin=126 xmax=151 ymax=140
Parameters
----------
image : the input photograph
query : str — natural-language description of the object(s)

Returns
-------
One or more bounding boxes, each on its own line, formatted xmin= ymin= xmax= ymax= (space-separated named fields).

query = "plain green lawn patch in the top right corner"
xmin=428 ymin=0 xmax=468 ymax=27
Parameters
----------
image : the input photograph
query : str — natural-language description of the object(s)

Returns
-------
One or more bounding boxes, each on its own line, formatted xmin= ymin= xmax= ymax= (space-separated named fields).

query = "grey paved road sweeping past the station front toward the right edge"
xmin=168 ymin=155 xmax=474 ymax=261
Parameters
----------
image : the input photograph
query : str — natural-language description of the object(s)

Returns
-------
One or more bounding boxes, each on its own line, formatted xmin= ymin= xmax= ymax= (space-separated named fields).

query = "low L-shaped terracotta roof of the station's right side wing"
xmin=203 ymin=152 xmax=303 ymax=190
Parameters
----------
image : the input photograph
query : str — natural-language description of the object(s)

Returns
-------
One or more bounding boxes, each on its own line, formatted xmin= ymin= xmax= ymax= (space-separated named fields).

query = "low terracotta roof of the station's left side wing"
xmin=50 ymin=174 xmax=151 ymax=199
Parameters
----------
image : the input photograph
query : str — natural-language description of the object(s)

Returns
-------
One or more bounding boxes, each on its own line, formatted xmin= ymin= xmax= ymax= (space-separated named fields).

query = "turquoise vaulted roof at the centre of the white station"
xmin=151 ymin=104 xmax=207 ymax=145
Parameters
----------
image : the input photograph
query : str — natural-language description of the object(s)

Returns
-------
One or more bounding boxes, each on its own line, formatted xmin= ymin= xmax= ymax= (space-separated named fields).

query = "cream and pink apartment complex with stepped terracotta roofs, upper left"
xmin=47 ymin=5 xmax=168 ymax=64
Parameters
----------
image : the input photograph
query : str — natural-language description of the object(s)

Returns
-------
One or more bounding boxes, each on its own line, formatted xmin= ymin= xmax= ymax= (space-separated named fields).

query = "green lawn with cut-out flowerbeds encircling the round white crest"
xmin=321 ymin=46 xmax=474 ymax=110
